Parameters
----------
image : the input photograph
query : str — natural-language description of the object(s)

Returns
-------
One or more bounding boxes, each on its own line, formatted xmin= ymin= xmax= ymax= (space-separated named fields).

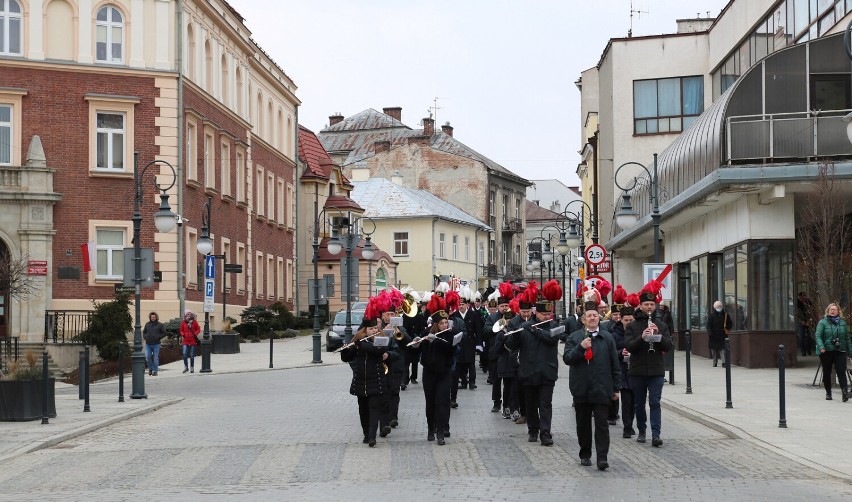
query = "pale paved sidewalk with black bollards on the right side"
xmin=662 ymin=352 xmax=852 ymax=479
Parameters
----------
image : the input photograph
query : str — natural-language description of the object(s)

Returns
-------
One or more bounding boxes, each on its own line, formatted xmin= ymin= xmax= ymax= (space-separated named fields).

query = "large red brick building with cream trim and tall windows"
xmin=0 ymin=0 xmax=299 ymax=340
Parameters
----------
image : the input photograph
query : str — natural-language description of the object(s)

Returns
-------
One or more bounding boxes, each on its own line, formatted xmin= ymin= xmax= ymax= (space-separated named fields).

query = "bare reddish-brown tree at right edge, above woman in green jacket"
xmin=798 ymin=162 xmax=852 ymax=312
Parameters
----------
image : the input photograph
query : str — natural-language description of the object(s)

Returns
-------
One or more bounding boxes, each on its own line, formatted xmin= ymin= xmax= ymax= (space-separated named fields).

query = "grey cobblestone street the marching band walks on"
xmin=0 ymin=365 xmax=852 ymax=501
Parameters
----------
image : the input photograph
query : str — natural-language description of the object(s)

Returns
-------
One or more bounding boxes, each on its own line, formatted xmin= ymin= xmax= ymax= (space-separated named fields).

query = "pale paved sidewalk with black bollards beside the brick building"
xmin=0 ymin=336 xmax=342 ymax=463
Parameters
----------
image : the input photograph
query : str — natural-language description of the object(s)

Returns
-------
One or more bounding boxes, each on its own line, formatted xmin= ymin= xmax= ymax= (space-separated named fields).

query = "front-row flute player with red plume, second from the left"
xmin=414 ymin=295 xmax=455 ymax=446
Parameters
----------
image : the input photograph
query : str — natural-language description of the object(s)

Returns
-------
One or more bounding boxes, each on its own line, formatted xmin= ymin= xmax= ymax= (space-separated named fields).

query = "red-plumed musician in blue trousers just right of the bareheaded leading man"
xmin=624 ymin=279 xmax=673 ymax=447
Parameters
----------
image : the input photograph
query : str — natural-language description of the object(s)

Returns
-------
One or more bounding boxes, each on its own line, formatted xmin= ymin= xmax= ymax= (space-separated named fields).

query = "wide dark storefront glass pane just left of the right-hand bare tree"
xmin=747 ymin=242 xmax=795 ymax=331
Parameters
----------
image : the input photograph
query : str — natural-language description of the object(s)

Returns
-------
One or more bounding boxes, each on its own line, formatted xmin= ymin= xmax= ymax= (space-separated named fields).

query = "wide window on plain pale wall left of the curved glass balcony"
xmin=633 ymin=76 xmax=704 ymax=134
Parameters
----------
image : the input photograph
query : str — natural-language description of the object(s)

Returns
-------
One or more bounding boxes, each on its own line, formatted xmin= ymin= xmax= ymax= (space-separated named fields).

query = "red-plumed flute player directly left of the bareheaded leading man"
xmin=506 ymin=281 xmax=562 ymax=446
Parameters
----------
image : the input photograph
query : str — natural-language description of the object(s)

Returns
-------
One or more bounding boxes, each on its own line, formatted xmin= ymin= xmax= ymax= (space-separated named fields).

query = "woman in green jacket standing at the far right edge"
xmin=816 ymin=303 xmax=852 ymax=403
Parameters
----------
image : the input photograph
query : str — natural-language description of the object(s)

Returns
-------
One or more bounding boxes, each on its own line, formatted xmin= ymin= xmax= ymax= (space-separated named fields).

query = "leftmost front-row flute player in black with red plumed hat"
xmin=340 ymin=303 xmax=399 ymax=448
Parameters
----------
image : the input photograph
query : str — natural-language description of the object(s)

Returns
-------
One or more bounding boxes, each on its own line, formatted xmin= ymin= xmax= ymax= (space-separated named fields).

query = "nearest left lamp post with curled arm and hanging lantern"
xmin=130 ymin=152 xmax=177 ymax=399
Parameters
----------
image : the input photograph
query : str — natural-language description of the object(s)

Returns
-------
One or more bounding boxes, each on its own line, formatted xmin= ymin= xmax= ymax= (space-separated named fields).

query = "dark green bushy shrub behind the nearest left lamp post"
xmin=77 ymin=295 xmax=133 ymax=361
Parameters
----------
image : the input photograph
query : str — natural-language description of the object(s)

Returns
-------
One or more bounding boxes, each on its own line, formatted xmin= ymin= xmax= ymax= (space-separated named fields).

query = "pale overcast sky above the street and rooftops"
xmin=229 ymin=0 xmax=728 ymax=185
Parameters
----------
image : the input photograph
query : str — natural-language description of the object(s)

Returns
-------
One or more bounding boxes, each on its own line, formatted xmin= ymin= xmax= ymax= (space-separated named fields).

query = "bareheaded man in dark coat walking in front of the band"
xmin=562 ymin=292 xmax=621 ymax=471
